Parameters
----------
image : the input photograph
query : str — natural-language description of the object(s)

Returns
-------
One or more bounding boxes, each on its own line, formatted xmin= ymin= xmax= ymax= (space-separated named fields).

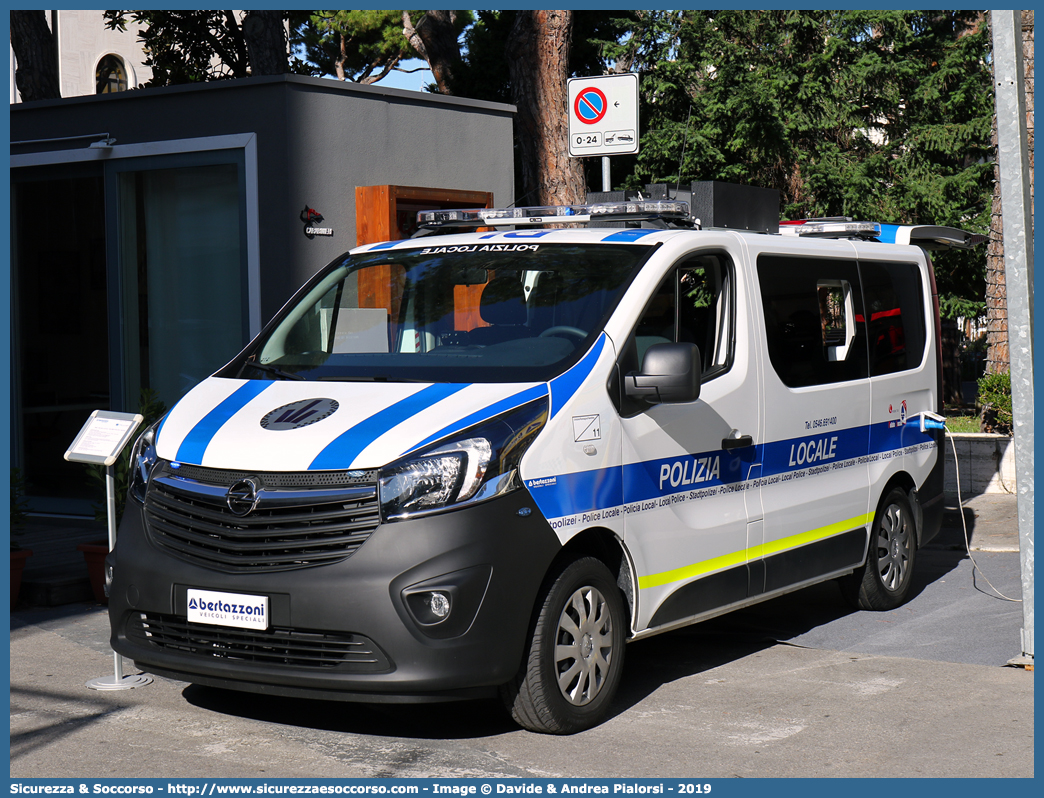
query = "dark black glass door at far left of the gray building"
xmin=10 ymin=169 xmax=111 ymax=514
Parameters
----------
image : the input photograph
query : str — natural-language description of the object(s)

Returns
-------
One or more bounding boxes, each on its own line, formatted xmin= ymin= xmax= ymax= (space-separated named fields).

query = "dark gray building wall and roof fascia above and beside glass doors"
xmin=10 ymin=75 xmax=515 ymax=323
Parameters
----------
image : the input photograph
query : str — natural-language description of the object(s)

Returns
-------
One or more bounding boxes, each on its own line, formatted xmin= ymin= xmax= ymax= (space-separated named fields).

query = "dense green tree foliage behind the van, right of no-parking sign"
xmin=612 ymin=9 xmax=993 ymax=314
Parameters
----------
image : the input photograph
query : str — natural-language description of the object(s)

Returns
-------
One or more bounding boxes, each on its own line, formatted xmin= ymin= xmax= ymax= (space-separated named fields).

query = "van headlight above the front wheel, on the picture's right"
xmin=380 ymin=397 xmax=548 ymax=521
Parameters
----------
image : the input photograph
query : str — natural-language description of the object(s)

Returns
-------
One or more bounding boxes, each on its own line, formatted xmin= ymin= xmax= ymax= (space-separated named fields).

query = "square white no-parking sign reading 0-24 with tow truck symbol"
xmin=568 ymin=72 xmax=638 ymax=158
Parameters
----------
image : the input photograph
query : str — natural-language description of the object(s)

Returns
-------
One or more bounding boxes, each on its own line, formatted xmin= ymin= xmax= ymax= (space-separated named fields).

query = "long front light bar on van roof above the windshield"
xmin=417 ymin=200 xmax=690 ymax=228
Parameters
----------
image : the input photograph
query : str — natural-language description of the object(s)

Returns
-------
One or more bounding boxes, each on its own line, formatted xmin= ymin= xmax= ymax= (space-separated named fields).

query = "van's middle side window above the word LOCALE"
xmin=758 ymin=255 xmax=868 ymax=388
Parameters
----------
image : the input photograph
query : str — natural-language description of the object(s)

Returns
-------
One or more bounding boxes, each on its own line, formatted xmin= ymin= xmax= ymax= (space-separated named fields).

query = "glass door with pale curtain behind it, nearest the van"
xmin=118 ymin=163 xmax=247 ymax=407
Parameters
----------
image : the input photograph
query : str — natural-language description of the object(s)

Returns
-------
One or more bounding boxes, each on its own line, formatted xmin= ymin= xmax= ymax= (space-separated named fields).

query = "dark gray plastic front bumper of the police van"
xmin=109 ymin=489 xmax=561 ymax=701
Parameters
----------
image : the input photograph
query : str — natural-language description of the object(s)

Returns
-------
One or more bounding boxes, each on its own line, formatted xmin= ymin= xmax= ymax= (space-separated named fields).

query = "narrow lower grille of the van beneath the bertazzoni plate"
xmin=126 ymin=612 xmax=392 ymax=674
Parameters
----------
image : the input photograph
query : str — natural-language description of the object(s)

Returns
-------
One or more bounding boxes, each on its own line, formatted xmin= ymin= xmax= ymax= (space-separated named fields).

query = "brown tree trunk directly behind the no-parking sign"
xmin=506 ymin=10 xmax=585 ymax=205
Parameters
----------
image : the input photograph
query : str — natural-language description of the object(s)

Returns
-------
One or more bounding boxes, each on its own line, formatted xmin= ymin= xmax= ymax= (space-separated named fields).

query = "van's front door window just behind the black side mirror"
xmin=635 ymin=255 xmax=734 ymax=380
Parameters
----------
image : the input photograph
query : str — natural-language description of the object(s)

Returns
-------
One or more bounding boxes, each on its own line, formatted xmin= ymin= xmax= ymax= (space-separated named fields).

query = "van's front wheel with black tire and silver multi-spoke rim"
xmin=501 ymin=557 xmax=627 ymax=734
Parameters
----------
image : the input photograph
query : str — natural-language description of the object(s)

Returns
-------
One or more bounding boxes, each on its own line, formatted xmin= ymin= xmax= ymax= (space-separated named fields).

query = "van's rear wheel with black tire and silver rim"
xmin=841 ymin=488 xmax=917 ymax=611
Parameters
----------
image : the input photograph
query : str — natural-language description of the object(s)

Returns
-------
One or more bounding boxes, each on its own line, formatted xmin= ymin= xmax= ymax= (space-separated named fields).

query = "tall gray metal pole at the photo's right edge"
xmin=991 ymin=10 xmax=1034 ymax=665
